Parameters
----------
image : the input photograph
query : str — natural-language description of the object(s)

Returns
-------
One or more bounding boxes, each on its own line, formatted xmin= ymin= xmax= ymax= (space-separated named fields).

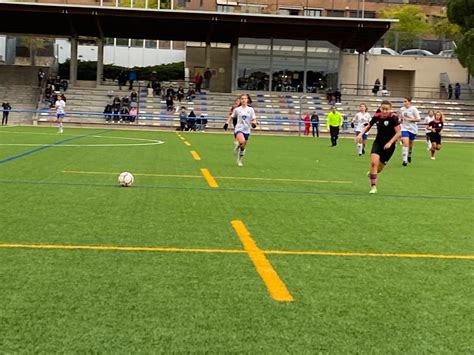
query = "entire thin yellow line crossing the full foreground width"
xmin=0 ymin=243 xmax=474 ymax=260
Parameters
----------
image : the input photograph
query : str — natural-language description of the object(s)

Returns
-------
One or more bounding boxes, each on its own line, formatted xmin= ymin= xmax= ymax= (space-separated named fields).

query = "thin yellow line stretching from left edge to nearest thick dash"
xmin=0 ymin=243 xmax=245 ymax=254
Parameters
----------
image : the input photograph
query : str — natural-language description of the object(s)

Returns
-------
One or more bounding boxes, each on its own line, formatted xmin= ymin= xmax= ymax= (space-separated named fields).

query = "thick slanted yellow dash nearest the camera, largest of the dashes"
xmin=231 ymin=220 xmax=293 ymax=302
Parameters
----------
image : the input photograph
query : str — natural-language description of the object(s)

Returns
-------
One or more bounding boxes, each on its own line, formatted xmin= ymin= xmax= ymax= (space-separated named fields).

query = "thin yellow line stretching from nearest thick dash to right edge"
xmin=265 ymin=250 xmax=474 ymax=260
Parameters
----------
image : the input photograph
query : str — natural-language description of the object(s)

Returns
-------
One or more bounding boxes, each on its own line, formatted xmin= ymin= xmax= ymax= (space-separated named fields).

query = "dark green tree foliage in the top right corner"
xmin=447 ymin=0 xmax=474 ymax=75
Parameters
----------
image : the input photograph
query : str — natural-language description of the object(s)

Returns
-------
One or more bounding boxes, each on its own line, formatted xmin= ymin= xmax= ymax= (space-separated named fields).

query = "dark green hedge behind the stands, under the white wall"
xmin=58 ymin=60 xmax=184 ymax=81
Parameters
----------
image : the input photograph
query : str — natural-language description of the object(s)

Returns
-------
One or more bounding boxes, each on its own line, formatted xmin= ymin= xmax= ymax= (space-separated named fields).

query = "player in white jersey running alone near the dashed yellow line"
xmin=224 ymin=94 xmax=257 ymax=166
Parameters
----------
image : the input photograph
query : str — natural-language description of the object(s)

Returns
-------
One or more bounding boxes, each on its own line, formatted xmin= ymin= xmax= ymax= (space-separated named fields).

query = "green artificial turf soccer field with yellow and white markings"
xmin=0 ymin=127 xmax=474 ymax=353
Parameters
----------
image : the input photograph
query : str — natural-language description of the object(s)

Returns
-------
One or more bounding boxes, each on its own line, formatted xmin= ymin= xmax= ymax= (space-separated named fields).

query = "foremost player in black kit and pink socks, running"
xmin=356 ymin=100 xmax=400 ymax=194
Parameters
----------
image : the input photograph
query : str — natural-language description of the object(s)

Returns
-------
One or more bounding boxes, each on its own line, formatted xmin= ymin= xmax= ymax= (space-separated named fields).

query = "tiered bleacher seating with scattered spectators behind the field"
xmin=53 ymin=86 xmax=474 ymax=138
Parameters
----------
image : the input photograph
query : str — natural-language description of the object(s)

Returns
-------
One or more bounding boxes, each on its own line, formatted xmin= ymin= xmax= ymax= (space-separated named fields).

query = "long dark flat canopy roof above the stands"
xmin=0 ymin=2 xmax=396 ymax=52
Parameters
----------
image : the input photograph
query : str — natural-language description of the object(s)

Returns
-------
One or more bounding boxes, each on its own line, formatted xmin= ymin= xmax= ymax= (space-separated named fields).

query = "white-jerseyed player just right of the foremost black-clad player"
xmin=399 ymin=97 xmax=421 ymax=166
